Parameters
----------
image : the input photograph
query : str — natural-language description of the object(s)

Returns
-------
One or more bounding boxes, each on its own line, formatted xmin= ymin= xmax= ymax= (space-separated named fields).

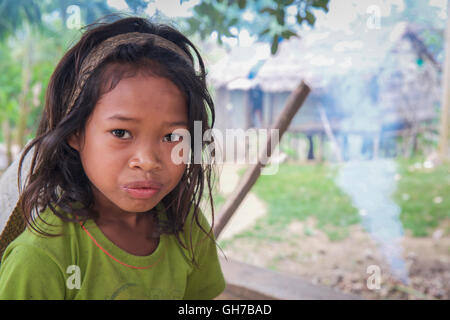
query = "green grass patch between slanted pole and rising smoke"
xmin=232 ymin=164 xmax=360 ymax=240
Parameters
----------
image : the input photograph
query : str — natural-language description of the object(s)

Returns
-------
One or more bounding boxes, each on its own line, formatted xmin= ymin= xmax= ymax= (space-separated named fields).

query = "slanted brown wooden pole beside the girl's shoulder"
xmin=214 ymin=81 xmax=311 ymax=238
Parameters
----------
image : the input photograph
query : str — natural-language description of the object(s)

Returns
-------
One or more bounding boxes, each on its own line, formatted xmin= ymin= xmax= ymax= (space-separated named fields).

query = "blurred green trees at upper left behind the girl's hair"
xmin=0 ymin=0 xmax=118 ymax=146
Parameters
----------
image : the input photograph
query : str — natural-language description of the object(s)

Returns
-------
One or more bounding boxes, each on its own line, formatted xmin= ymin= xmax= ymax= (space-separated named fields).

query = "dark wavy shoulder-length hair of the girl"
xmin=19 ymin=17 xmax=219 ymax=260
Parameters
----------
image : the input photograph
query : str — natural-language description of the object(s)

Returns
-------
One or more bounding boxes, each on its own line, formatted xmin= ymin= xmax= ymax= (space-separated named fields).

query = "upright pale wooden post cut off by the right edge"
xmin=439 ymin=0 xmax=450 ymax=161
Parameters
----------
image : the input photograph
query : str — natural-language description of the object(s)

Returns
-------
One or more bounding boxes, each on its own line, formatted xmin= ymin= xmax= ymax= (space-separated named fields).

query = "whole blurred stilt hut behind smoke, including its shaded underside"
xmin=210 ymin=23 xmax=441 ymax=165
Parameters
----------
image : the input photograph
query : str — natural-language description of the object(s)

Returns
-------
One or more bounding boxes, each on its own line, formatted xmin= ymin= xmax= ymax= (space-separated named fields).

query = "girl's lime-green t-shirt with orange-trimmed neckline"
xmin=0 ymin=204 xmax=225 ymax=300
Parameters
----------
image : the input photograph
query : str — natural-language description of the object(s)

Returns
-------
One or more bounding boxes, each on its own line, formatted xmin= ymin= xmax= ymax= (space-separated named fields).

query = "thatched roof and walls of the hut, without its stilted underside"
xmin=211 ymin=23 xmax=441 ymax=160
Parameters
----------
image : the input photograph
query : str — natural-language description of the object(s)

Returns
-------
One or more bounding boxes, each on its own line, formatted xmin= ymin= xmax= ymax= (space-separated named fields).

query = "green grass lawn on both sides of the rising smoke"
xmin=222 ymin=159 xmax=450 ymax=241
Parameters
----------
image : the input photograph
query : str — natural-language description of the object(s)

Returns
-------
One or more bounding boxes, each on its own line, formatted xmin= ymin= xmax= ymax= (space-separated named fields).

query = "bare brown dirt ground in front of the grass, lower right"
xmin=224 ymin=219 xmax=450 ymax=299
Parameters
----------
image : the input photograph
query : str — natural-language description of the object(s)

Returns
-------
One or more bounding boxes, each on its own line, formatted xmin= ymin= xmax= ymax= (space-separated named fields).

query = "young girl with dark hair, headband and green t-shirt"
xmin=0 ymin=17 xmax=225 ymax=299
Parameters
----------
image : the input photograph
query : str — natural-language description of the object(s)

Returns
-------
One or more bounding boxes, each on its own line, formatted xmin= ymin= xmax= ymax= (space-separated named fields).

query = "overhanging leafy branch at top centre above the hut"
xmin=187 ymin=0 xmax=329 ymax=54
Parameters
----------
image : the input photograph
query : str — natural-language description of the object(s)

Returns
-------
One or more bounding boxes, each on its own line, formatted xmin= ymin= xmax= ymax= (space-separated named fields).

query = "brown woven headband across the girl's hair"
xmin=66 ymin=32 xmax=193 ymax=115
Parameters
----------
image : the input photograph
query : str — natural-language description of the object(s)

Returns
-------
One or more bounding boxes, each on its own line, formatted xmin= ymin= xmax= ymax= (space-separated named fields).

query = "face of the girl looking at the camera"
xmin=69 ymin=74 xmax=188 ymax=213
